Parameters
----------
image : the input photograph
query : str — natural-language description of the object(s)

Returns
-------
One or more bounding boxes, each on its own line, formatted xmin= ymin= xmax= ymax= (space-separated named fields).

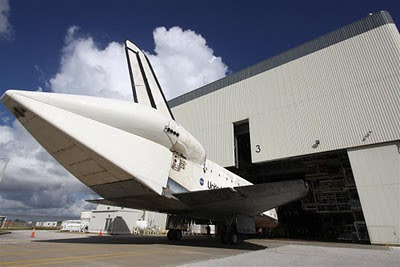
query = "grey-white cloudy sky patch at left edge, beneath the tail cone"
xmin=0 ymin=120 xmax=93 ymax=216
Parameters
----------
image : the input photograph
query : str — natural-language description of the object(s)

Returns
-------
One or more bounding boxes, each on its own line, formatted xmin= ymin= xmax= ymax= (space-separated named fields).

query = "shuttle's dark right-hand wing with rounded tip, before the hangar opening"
xmin=174 ymin=180 xmax=308 ymax=216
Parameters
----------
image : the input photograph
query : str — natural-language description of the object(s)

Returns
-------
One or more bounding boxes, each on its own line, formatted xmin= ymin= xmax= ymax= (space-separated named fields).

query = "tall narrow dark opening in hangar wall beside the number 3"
xmin=233 ymin=120 xmax=251 ymax=174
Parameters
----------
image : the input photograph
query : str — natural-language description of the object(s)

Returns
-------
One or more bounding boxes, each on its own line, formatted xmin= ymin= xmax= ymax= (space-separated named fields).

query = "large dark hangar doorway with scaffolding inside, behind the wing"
xmin=228 ymin=150 xmax=369 ymax=243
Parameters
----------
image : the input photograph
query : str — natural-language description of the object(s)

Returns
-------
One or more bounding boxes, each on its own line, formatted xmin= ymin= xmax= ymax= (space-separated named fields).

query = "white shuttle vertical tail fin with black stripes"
xmin=125 ymin=40 xmax=174 ymax=119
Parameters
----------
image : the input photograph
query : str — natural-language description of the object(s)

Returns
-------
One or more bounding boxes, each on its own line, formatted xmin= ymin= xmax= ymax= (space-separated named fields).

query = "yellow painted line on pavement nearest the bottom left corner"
xmin=0 ymin=250 xmax=166 ymax=265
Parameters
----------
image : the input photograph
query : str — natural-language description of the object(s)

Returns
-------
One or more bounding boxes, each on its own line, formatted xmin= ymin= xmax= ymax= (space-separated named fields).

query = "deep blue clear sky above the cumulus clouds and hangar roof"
xmin=0 ymin=0 xmax=400 ymax=98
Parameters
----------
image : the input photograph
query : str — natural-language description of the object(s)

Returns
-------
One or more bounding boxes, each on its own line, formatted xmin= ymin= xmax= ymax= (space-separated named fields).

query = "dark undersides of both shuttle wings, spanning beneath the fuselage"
xmin=87 ymin=180 xmax=308 ymax=217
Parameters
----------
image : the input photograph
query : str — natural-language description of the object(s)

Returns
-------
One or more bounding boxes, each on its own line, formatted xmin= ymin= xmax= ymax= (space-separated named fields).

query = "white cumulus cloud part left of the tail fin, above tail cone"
xmin=49 ymin=26 xmax=132 ymax=100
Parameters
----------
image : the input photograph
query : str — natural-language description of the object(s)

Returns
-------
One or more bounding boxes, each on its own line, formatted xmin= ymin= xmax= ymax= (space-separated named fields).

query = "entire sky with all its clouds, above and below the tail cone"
xmin=0 ymin=0 xmax=400 ymax=218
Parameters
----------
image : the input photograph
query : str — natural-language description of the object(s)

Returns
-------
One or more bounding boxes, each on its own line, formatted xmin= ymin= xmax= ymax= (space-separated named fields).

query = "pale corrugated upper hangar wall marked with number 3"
xmin=171 ymin=13 xmax=400 ymax=166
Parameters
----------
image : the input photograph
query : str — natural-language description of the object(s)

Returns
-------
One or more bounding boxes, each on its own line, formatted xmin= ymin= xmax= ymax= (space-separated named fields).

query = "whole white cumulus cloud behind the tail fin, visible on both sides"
xmin=49 ymin=26 xmax=228 ymax=100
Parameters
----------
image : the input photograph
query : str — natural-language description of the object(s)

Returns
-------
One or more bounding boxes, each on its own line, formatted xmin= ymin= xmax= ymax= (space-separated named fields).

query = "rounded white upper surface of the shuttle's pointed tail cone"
xmin=2 ymin=90 xmax=171 ymax=148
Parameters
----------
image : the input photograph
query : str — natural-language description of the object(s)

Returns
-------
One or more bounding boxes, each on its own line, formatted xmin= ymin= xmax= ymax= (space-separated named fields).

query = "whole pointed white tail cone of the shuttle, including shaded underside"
xmin=1 ymin=90 xmax=172 ymax=194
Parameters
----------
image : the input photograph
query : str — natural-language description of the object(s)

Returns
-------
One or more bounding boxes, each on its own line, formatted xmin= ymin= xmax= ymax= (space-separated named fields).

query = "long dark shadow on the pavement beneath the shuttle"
xmin=34 ymin=235 xmax=267 ymax=250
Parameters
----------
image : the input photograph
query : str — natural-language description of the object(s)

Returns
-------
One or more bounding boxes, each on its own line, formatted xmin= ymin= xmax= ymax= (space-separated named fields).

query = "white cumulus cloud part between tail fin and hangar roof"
xmin=148 ymin=27 xmax=228 ymax=99
